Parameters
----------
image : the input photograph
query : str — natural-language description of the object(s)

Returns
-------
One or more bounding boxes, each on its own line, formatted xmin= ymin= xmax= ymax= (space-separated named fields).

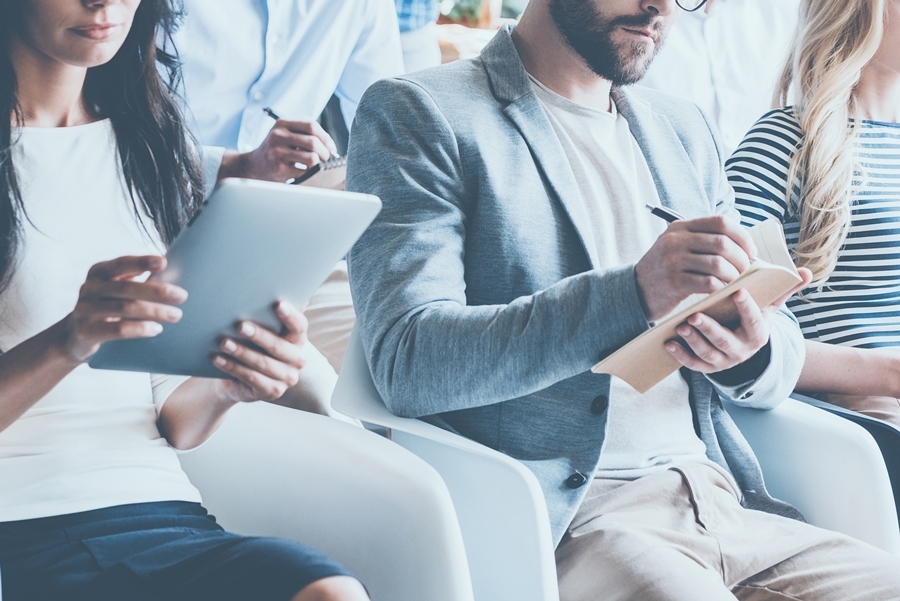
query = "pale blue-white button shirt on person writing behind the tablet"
xmin=174 ymin=0 xmax=403 ymax=152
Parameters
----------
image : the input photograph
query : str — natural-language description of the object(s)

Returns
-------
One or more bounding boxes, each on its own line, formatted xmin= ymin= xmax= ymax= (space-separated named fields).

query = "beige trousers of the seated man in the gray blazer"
xmin=556 ymin=464 xmax=900 ymax=601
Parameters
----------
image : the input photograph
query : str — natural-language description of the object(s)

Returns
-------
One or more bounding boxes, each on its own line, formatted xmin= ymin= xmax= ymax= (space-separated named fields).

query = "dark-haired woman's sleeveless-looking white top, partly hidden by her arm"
xmin=0 ymin=121 xmax=200 ymax=522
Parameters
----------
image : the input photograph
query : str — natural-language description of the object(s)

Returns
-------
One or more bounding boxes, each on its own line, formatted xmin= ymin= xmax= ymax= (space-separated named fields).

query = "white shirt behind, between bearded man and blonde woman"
xmin=640 ymin=0 xmax=800 ymax=157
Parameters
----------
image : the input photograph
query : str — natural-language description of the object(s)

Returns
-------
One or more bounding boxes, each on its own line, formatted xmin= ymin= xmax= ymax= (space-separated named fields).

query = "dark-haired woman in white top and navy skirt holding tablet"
xmin=0 ymin=0 xmax=368 ymax=601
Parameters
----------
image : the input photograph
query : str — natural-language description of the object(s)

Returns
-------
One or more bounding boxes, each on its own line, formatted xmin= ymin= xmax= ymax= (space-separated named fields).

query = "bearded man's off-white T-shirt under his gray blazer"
xmin=531 ymin=78 xmax=711 ymax=480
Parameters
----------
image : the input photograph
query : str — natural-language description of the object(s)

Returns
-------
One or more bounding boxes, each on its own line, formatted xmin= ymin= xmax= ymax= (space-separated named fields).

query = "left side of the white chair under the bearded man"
xmin=332 ymin=332 xmax=559 ymax=601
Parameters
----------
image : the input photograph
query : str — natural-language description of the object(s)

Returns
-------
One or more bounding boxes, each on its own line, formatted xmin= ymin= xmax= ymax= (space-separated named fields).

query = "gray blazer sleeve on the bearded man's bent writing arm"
xmin=347 ymin=79 xmax=648 ymax=417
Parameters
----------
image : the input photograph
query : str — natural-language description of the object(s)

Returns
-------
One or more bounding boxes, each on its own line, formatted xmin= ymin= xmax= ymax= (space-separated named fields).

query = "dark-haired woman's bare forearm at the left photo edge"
xmin=0 ymin=322 xmax=80 ymax=432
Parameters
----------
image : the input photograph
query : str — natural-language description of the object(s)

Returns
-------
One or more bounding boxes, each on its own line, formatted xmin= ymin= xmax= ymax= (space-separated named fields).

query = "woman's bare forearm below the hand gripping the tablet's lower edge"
xmin=157 ymin=378 xmax=235 ymax=450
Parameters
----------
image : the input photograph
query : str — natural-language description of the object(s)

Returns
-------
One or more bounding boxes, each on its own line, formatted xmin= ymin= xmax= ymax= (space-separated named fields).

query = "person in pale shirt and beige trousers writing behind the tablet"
xmin=172 ymin=0 xmax=404 ymax=412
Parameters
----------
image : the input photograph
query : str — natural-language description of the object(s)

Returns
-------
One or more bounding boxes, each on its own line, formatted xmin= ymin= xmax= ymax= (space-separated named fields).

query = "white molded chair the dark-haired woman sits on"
xmin=174 ymin=403 xmax=473 ymax=601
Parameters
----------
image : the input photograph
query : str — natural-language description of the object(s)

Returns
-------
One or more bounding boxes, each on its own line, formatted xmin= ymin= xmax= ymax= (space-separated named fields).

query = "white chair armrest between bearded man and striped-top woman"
xmin=726 ymin=399 xmax=900 ymax=554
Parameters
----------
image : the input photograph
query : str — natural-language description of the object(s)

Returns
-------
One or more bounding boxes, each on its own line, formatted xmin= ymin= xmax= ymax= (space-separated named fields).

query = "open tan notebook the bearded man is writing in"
xmin=591 ymin=219 xmax=802 ymax=394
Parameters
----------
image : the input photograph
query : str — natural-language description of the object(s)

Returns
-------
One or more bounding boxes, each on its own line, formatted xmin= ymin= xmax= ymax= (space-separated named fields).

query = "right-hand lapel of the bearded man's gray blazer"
xmin=612 ymin=88 xmax=710 ymax=218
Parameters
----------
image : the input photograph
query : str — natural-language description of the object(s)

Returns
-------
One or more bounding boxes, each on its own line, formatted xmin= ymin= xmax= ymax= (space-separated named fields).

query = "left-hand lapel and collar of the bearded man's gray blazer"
xmin=481 ymin=25 xmax=599 ymax=268
